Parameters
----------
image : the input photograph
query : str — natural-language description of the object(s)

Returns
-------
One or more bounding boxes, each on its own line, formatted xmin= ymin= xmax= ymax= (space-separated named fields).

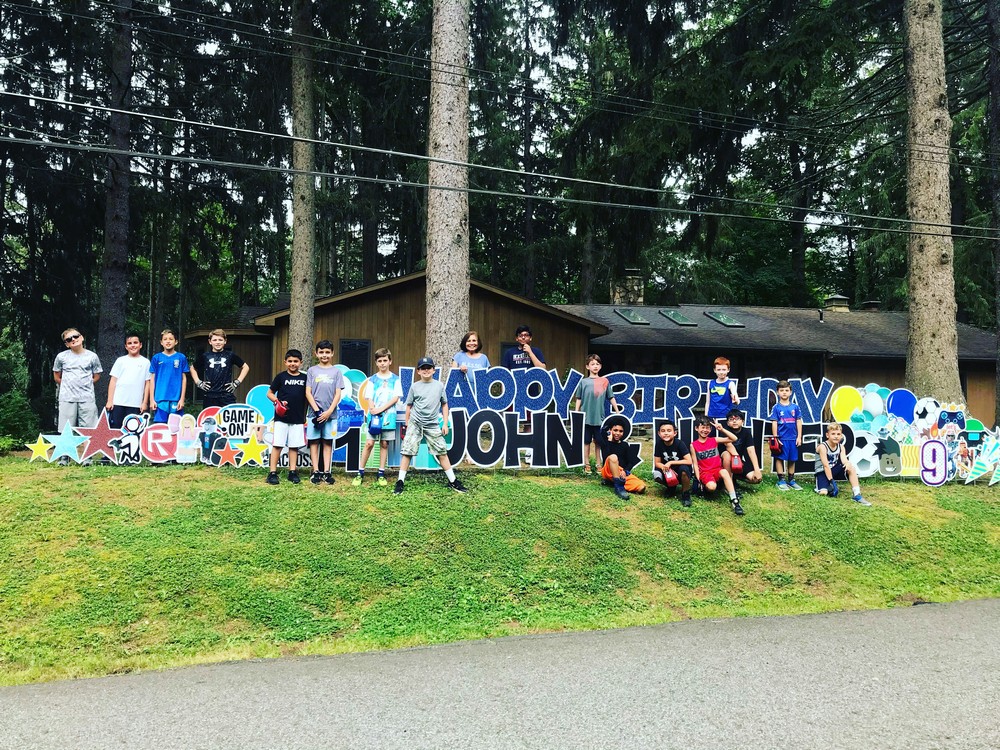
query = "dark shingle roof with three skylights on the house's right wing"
xmin=554 ymin=305 xmax=996 ymax=360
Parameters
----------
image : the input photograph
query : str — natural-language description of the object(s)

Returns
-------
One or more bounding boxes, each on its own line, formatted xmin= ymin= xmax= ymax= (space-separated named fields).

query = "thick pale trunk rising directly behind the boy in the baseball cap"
xmin=426 ymin=0 xmax=469 ymax=364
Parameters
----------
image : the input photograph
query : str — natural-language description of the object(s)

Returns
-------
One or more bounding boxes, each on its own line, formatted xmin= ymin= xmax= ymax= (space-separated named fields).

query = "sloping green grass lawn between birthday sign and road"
xmin=0 ymin=457 xmax=1000 ymax=684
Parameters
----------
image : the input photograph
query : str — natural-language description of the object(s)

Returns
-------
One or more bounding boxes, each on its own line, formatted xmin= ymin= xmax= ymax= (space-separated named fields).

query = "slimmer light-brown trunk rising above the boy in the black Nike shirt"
xmin=288 ymin=0 xmax=316 ymax=364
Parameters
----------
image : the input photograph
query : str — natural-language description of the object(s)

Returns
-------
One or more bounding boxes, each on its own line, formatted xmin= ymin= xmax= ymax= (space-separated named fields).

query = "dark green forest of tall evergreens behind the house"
xmin=0 ymin=0 xmax=1000 ymax=438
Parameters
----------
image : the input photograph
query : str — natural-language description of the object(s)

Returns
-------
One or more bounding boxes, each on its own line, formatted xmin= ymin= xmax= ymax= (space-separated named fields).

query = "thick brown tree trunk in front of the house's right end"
xmin=903 ymin=0 xmax=963 ymax=401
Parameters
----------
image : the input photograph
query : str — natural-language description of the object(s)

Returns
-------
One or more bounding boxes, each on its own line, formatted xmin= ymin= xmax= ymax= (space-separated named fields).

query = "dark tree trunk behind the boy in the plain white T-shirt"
xmin=97 ymin=0 xmax=132 ymax=405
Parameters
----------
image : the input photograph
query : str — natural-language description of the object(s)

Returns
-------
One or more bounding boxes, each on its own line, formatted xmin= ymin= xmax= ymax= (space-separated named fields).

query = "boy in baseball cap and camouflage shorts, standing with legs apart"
xmin=392 ymin=357 xmax=467 ymax=495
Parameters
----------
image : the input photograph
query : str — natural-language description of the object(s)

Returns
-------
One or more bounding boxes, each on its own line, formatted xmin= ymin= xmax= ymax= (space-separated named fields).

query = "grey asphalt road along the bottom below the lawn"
xmin=0 ymin=600 xmax=1000 ymax=750
